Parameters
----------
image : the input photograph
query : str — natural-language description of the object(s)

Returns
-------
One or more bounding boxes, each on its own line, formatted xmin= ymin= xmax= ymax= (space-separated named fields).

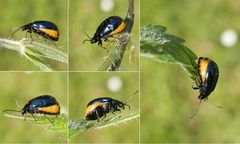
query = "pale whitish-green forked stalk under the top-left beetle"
xmin=0 ymin=38 xmax=68 ymax=71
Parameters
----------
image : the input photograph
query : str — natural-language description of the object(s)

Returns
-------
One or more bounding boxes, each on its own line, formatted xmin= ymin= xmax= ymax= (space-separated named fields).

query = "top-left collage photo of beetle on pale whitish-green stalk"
xmin=0 ymin=0 xmax=68 ymax=71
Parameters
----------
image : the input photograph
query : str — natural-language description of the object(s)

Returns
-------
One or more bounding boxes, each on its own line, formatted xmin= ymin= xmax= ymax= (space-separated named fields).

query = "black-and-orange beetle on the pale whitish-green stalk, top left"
xmin=9 ymin=21 xmax=59 ymax=41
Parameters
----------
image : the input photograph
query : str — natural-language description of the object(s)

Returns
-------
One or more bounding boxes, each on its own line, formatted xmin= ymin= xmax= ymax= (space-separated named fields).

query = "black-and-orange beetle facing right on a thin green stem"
xmin=85 ymin=97 xmax=130 ymax=121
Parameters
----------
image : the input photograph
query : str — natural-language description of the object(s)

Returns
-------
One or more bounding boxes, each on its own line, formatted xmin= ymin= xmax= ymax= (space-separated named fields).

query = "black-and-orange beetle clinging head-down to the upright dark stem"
xmin=83 ymin=16 xmax=127 ymax=47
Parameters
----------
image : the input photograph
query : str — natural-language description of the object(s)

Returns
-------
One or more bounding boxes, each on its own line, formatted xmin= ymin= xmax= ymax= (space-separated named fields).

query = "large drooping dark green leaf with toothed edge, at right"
xmin=140 ymin=25 xmax=199 ymax=83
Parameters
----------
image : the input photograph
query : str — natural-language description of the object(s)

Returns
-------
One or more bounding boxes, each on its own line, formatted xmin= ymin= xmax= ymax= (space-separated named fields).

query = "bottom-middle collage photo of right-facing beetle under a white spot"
xmin=69 ymin=72 xmax=140 ymax=143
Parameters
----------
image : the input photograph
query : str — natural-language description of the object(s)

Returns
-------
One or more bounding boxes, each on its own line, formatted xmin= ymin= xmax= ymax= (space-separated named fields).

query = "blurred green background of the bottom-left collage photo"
xmin=0 ymin=72 xmax=68 ymax=143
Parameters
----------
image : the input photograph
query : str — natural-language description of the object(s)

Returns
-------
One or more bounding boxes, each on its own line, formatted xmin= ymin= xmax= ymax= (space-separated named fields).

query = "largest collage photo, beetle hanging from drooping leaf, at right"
xmin=140 ymin=0 xmax=240 ymax=143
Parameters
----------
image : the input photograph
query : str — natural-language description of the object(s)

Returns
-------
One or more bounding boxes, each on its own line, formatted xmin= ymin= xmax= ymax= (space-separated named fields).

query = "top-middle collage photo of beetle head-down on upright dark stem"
xmin=69 ymin=0 xmax=140 ymax=71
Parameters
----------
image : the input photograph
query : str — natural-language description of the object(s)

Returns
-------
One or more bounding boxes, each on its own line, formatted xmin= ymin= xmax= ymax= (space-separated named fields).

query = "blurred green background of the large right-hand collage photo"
xmin=140 ymin=0 xmax=240 ymax=143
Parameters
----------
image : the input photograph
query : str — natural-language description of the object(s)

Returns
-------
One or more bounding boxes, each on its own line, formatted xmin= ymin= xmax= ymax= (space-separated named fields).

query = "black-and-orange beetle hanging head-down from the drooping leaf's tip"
xmin=191 ymin=57 xmax=219 ymax=118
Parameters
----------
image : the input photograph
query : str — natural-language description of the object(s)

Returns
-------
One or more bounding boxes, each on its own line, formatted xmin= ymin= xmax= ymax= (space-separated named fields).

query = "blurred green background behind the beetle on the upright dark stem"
xmin=69 ymin=0 xmax=139 ymax=71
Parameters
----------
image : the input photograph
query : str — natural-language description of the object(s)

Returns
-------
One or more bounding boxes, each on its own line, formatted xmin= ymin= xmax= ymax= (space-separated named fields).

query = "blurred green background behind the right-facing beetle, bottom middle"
xmin=69 ymin=72 xmax=139 ymax=143
